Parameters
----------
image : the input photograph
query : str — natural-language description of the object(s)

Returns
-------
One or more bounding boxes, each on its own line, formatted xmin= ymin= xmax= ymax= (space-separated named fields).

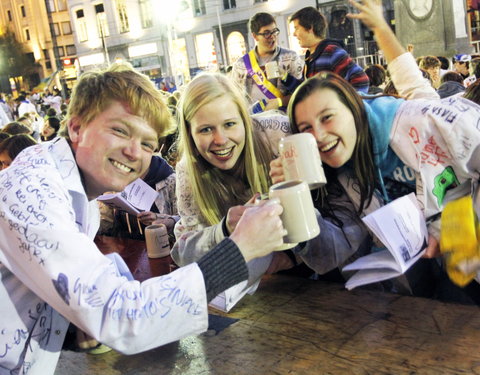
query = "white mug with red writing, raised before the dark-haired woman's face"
xmin=278 ymin=133 xmax=327 ymax=189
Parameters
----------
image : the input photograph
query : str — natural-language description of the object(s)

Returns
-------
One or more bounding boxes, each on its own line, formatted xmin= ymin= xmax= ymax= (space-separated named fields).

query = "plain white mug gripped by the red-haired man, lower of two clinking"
xmin=269 ymin=180 xmax=320 ymax=243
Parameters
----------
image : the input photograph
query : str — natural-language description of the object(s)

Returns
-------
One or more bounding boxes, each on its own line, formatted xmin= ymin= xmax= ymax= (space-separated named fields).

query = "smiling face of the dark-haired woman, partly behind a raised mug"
xmin=295 ymin=88 xmax=357 ymax=168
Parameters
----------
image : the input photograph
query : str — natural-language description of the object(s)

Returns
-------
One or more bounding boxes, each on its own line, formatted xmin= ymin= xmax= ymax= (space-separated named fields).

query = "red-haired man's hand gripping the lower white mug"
xmin=230 ymin=201 xmax=287 ymax=262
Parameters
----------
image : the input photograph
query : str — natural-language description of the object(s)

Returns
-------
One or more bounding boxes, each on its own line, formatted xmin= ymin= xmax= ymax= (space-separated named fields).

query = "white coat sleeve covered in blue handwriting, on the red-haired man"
xmin=0 ymin=151 xmax=208 ymax=353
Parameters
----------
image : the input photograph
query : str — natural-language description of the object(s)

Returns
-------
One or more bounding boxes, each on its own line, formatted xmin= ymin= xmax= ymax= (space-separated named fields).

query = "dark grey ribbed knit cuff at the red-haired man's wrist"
xmin=197 ymin=238 xmax=248 ymax=302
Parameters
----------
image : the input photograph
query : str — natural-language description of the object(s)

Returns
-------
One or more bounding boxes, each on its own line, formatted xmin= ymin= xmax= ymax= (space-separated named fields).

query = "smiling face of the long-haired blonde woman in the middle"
xmin=190 ymin=95 xmax=245 ymax=171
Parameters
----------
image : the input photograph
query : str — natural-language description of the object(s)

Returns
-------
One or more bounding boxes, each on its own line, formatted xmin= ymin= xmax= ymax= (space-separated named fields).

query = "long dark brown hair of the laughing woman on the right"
xmin=288 ymin=72 xmax=376 ymax=214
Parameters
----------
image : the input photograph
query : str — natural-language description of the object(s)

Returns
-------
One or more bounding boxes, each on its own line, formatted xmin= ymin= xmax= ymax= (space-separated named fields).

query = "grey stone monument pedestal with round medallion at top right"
xmin=395 ymin=0 xmax=472 ymax=57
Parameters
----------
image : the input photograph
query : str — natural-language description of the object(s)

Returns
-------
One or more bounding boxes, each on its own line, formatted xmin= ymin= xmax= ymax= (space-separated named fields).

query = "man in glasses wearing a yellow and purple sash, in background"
xmin=231 ymin=13 xmax=304 ymax=112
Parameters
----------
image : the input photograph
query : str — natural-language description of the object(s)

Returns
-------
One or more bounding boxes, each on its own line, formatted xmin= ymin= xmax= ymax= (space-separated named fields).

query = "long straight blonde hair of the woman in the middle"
xmin=178 ymin=73 xmax=273 ymax=225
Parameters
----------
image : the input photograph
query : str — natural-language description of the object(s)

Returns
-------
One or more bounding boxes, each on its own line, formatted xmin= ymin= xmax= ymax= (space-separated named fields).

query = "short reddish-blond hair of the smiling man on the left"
xmin=61 ymin=63 xmax=174 ymax=142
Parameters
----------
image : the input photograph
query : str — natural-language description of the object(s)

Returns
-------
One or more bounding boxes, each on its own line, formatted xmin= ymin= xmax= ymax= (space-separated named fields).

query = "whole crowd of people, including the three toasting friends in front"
xmin=0 ymin=0 xmax=480 ymax=374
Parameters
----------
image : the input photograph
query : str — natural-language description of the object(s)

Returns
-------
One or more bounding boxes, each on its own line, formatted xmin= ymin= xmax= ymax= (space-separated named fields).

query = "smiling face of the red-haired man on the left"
xmin=68 ymin=102 xmax=158 ymax=199
